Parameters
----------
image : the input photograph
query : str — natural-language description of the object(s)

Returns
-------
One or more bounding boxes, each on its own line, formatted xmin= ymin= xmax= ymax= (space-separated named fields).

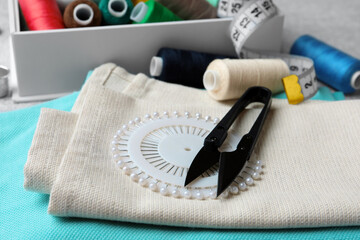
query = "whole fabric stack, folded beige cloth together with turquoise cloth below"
xmin=0 ymin=64 xmax=360 ymax=239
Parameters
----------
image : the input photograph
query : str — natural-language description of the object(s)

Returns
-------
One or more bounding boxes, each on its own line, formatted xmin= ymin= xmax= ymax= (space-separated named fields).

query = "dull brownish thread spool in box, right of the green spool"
xmin=157 ymin=0 xmax=217 ymax=20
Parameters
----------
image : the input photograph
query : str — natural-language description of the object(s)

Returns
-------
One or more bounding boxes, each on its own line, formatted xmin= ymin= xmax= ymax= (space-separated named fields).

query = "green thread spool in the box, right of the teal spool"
xmin=130 ymin=0 xmax=182 ymax=23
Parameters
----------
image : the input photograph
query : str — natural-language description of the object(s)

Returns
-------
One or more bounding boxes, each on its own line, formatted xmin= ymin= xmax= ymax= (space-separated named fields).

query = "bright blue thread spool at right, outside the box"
xmin=290 ymin=35 xmax=360 ymax=93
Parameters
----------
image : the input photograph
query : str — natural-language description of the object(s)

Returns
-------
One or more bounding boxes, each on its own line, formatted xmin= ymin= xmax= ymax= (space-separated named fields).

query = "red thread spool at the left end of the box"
xmin=19 ymin=0 xmax=64 ymax=31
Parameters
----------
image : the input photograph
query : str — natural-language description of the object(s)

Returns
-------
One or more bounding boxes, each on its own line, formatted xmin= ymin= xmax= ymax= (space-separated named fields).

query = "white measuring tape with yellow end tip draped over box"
xmin=226 ymin=0 xmax=317 ymax=104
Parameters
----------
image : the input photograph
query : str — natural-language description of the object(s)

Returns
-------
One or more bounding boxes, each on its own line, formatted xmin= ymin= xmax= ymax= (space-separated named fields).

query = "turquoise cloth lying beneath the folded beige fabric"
xmin=0 ymin=87 xmax=360 ymax=240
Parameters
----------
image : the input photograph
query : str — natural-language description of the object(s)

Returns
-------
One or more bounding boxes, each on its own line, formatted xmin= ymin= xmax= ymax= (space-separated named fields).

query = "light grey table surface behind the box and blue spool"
xmin=0 ymin=0 xmax=360 ymax=112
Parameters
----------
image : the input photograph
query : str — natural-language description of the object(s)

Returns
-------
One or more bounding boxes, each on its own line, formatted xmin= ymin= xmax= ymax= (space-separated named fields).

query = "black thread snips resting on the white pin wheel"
xmin=185 ymin=87 xmax=272 ymax=196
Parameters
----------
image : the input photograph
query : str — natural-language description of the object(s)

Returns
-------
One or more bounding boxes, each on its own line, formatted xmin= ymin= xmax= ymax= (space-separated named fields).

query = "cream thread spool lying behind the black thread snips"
xmin=203 ymin=59 xmax=289 ymax=100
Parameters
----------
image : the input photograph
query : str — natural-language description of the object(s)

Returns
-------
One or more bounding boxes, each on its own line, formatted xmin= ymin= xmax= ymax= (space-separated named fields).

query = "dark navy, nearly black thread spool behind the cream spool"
xmin=150 ymin=48 xmax=234 ymax=89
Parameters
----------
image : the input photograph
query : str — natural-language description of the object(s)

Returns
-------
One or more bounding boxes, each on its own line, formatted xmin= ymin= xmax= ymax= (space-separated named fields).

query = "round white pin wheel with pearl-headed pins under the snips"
xmin=111 ymin=111 xmax=262 ymax=199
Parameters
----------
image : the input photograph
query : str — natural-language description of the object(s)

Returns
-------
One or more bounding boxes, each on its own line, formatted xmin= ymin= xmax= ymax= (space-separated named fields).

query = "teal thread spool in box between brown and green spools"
xmin=99 ymin=0 xmax=134 ymax=25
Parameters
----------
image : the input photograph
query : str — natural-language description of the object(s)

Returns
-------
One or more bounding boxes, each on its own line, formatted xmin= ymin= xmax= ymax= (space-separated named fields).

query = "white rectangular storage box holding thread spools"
xmin=8 ymin=0 xmax=284 ymax=102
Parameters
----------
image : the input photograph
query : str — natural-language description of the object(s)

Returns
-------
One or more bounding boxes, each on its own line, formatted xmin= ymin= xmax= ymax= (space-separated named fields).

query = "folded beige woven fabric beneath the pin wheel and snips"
xmin=25 ymin=65 xmax=360 ymax=228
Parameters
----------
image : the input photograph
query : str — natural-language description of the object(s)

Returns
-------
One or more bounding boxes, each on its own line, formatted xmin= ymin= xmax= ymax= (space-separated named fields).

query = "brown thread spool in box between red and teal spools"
xmin=64 ymin=0 xmax=101 ymax=28
